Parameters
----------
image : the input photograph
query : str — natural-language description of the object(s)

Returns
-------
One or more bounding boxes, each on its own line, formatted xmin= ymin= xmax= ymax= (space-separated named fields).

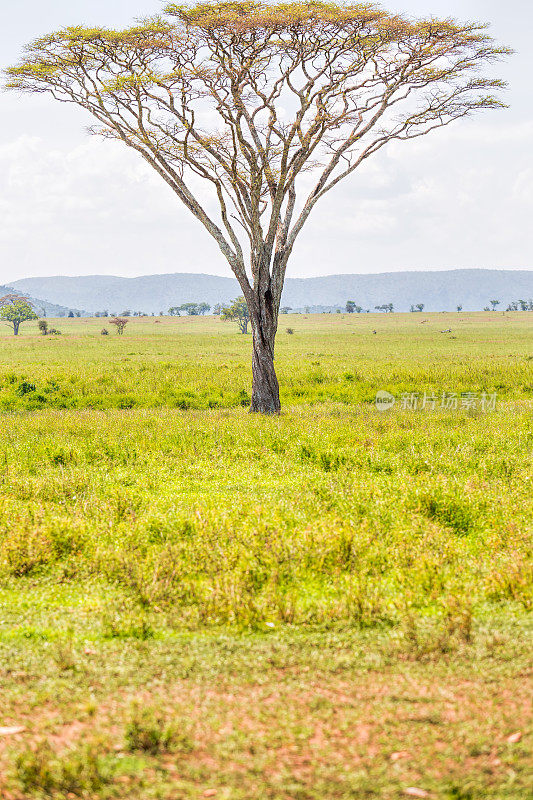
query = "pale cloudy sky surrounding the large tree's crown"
xmin=0 ymin=0 xmax=533 ymax=284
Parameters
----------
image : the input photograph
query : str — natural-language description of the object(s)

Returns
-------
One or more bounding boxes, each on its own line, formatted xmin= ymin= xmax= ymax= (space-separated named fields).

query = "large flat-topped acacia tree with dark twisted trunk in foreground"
xmin=7 ymin=0 xmax=510 ymax=412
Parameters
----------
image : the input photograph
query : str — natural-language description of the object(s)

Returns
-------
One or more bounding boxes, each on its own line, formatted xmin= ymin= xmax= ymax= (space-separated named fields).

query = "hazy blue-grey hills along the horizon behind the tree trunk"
xmin=8 ymin=269 xmax=533 ymax=314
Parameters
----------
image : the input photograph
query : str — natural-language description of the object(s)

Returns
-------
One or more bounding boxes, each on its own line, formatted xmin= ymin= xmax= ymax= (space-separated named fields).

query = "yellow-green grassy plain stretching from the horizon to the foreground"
xmin=0 ymin=313 xmax=533 ymax=800
